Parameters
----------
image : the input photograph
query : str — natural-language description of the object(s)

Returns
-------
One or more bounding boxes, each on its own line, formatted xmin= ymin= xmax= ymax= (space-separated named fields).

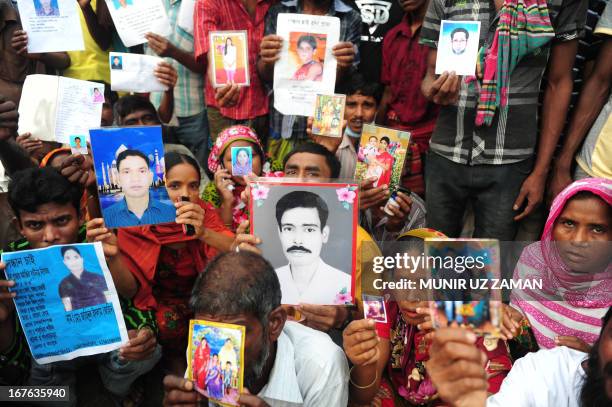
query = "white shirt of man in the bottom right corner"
xmin=487 ymin=346 xmax=587 ymax=407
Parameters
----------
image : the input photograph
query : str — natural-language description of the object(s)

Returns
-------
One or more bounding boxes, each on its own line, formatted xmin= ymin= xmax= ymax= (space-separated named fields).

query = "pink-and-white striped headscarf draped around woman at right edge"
xmin=511 ymin=178 xmax=612 ymax=348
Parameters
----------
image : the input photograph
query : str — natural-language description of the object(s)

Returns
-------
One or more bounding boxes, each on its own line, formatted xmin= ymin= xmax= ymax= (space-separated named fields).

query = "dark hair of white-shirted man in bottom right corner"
xmin=580 ymin=307 xmax=612 ymax=407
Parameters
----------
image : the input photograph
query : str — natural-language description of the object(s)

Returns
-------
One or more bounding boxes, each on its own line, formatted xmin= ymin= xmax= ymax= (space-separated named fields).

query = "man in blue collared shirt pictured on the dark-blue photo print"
xmin=104 ymin=150 xmax=176 ymax=227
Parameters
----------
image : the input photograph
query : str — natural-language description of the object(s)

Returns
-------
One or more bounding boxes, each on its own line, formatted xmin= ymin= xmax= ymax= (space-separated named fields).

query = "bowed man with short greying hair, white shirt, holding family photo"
xmin=163 ymin=251 xmax=348 ymax=407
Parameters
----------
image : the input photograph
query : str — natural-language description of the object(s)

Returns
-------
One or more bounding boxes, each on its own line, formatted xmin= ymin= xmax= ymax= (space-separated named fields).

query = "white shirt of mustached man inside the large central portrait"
xmin=276 ymin=258 xmax=351 ymax=305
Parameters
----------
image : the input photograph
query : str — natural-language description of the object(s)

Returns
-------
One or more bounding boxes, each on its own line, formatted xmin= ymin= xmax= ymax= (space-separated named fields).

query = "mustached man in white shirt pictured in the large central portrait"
xmin=276 ymin=191 xmax=351 ymax=305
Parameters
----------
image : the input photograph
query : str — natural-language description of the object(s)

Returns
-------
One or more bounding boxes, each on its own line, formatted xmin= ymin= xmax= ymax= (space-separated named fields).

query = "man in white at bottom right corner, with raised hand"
xmin=426 ymin=308 xmax=612 ymax=407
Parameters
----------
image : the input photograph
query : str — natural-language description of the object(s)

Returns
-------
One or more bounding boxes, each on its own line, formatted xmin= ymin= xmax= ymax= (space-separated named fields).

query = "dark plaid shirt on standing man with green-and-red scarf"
xmin=421 ymin=0 xmax=586 ymax=165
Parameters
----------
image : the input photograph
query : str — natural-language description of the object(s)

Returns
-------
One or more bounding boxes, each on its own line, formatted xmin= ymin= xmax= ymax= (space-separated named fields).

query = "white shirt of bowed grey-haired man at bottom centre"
xmin=257 ymin=321 xmax=349 ymax=407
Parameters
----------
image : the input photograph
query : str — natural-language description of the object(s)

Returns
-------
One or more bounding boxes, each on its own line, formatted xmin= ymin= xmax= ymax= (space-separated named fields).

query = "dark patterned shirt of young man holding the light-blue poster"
xmin=0 ymin=225 xmax=158 ymax=386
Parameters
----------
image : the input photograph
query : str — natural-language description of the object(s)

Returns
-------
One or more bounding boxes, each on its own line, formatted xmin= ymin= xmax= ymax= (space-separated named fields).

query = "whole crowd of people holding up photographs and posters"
xmin=0 ymin=0 xmax=612 ymax=407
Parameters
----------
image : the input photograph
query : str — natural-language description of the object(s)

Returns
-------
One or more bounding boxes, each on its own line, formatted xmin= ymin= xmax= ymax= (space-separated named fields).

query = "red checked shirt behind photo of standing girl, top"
xmin=193 ymin=0 xmax=274 ymax=120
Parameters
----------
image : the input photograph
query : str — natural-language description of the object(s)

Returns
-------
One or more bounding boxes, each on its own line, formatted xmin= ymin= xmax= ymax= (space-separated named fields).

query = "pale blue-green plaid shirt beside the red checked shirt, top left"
xmin=145 ymin=0 xmax=205 ymax=117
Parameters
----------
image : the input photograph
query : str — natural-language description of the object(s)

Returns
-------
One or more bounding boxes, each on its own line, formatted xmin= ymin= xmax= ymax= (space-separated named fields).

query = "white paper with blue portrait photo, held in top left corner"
xmin=17 ymin=0 xmax=85 ymax=54
